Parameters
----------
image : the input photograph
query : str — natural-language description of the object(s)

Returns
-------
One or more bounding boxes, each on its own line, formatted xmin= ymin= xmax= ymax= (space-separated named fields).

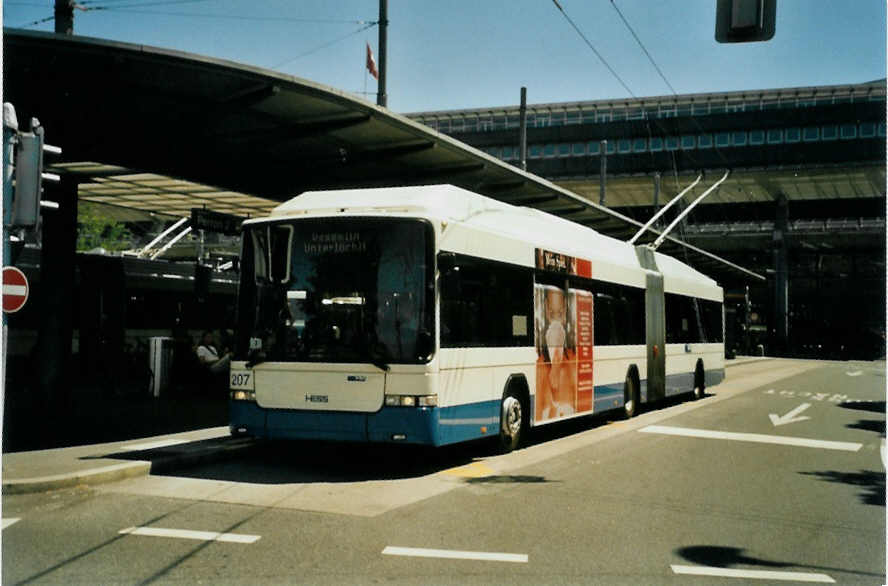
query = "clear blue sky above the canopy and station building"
xmin=2 ymin=0 xmax=886 ymax=113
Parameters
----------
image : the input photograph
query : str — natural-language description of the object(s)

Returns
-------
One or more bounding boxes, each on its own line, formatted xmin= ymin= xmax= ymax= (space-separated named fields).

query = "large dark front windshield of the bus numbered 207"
xmin=237 ymin=218 xmax=434 ymax=370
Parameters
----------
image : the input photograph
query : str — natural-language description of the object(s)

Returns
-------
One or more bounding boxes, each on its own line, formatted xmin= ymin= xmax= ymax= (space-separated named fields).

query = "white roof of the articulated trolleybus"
xmin=260 ymin=185 xmax=721 ymax=299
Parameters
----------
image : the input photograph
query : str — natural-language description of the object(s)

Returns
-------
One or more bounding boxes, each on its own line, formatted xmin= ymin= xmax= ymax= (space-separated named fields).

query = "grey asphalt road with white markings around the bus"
xmin=2 ymin=361 xmax=886 ymax=584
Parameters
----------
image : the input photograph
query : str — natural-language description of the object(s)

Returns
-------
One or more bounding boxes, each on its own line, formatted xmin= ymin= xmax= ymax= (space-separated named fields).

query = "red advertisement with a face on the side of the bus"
xmin=534 ymin=250 xmax=595 ymax=422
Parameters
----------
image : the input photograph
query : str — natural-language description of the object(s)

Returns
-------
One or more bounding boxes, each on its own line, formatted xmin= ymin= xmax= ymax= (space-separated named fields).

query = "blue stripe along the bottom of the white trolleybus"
xmin=229 ymin=369 xmax=724 ymax=446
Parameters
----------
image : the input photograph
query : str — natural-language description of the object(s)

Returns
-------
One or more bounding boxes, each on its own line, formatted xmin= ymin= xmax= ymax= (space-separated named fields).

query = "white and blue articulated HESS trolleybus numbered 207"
xmin=230 ymin=185 xmax=724 ymax=450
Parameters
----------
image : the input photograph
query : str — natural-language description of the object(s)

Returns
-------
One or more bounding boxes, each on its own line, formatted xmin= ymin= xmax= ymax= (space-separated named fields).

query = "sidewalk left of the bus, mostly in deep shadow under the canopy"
xmin=2 ymin=378 xmax=253 ymax=494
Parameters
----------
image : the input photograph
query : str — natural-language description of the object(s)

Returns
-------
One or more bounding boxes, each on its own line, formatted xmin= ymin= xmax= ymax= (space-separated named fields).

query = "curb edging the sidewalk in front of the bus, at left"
xmin=3 ymin=438 xmax=257 ymax=495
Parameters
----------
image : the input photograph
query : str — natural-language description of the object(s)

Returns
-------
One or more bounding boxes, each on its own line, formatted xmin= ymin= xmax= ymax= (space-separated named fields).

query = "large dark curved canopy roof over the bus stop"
xmin=3 ymin=29 xmax=762 ymax=278
